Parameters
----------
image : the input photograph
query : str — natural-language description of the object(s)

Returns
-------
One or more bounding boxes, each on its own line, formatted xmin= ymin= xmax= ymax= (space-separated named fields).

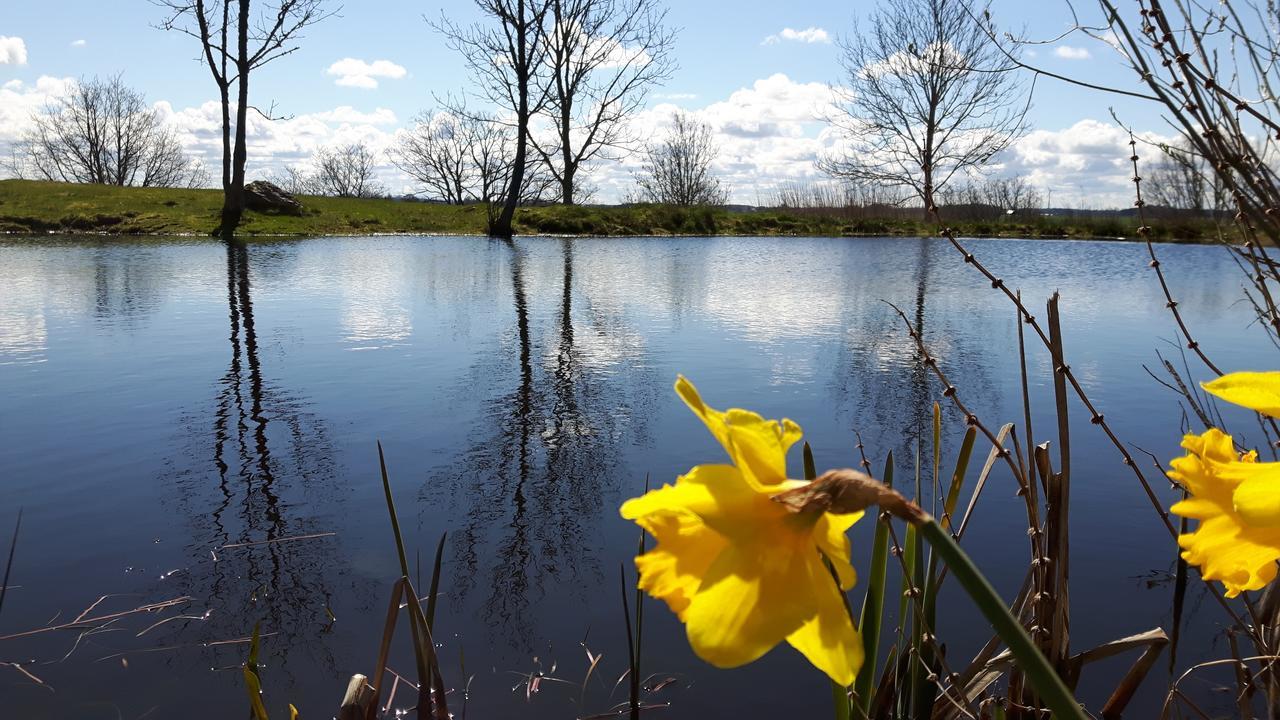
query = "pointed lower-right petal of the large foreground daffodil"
xmin=787 ymin=553 xmax=863 ymax=687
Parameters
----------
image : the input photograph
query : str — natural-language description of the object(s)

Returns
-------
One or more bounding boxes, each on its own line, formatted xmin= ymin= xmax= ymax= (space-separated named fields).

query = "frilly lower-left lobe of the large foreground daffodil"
xmin=636 ymin=512 xmax=726 ymax=620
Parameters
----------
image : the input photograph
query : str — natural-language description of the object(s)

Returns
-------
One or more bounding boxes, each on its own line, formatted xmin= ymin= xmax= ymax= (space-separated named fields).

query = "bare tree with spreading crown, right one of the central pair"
xmin=530 ymin=0 xmax=675 ymax=205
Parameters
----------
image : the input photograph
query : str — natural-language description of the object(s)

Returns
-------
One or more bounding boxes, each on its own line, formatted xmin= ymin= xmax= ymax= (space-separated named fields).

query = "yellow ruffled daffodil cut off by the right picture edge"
xmin=1169 ymin=373 xmax=1280 ymax=597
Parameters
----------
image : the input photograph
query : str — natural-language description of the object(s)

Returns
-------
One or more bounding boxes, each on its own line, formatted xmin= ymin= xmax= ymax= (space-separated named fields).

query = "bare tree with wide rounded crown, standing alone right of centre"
xmin=819 ymin=0 xmax=1025 ymax=213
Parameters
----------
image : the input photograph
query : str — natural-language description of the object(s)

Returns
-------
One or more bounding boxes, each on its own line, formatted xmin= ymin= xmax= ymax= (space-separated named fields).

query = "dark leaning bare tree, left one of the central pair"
xmin=435 ymin=0 xmax=550 ymax=238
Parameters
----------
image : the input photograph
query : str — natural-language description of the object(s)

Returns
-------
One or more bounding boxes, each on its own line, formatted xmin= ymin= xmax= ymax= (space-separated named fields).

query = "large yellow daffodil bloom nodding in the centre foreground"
xmin=621 ymin=377 xmax=863 ymax=685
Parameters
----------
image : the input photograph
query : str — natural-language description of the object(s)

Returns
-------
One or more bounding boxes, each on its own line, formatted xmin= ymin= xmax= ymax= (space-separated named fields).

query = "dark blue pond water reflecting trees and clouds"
xmin=0 ymin=237 xmax=1274 ymax=719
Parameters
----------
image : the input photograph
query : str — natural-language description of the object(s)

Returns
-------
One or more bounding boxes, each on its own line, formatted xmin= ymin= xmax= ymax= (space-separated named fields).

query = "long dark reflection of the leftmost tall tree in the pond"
xmin=167 ymin=242 xmax=343 ymax=671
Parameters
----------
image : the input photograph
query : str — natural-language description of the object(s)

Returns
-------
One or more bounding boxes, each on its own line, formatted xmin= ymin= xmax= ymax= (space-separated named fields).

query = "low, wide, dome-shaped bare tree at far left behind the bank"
xmin=10 ymin=76 xmax=206 ymax=187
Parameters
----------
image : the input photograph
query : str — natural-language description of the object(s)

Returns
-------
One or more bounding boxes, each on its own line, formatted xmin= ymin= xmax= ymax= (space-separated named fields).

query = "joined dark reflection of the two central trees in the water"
xmin=435 ymin=238 xmax=660 ymax=650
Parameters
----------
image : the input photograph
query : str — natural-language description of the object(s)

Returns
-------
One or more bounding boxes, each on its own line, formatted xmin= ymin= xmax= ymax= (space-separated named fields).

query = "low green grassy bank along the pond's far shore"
xmin=0 ymin=181 xmax=1212 ymax=241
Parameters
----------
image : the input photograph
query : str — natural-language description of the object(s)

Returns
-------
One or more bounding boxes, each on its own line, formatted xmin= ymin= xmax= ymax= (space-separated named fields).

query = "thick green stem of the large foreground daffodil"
xmin=916 ymin=518 xmax=1087 ymax=720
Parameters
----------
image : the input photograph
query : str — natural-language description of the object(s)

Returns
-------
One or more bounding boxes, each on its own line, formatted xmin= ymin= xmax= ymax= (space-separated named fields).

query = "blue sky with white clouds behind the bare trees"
xmin=0 ymin=0 xmax=1174 ymax=208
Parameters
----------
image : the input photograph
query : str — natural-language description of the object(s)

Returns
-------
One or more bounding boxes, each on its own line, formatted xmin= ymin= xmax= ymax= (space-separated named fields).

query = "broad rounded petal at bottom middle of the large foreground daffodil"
xmin=685 ymin=538 xmax=813 ymax=667
